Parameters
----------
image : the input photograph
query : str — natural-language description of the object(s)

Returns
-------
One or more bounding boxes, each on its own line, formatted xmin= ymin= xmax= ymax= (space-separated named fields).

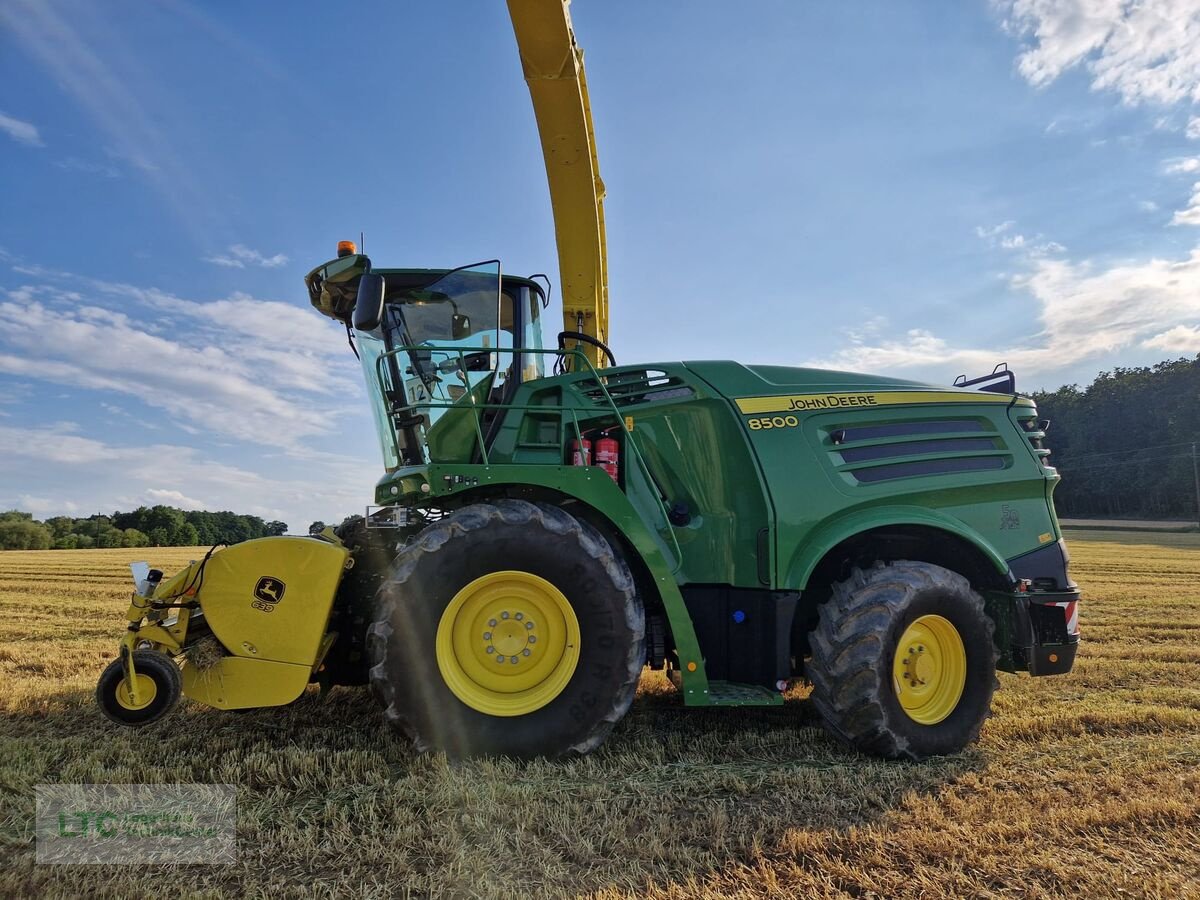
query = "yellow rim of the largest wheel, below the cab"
xmin=437 ymin=571 xmax=580 ymax=715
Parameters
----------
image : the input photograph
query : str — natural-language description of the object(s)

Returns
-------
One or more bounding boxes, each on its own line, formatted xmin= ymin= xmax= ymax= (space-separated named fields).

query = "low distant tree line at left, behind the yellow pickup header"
xmin=0 ymin=506 xmax=288 ymax=550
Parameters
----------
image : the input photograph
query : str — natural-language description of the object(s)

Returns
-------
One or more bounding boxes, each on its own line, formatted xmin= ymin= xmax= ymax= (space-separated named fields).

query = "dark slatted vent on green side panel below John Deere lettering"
xmin=826 ymin=419 xmax=1012 ymax=484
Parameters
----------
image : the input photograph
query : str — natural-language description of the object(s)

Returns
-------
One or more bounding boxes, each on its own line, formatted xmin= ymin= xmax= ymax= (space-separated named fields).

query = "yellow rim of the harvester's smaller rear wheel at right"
xmin=892 ymin=616 xmax=967 ymax=725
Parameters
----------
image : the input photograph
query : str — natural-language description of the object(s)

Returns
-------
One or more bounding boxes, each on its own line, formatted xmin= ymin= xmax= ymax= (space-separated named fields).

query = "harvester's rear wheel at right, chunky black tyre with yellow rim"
xmin=806 ymin=560 xmax=996 ymax=760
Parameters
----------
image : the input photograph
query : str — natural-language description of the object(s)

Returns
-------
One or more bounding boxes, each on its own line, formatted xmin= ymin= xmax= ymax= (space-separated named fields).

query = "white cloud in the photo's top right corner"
xmin=1000 ymin=0 xmax=1200 ymax=106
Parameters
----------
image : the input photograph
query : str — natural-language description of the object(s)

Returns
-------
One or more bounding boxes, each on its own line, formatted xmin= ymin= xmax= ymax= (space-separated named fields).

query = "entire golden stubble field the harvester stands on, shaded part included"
xmin=0 ymin=533 xmax=1200 ymax=899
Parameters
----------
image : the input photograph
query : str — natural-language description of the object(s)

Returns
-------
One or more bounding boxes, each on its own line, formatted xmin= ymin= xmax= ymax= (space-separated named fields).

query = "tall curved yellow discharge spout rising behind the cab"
xmin=508 ymin=0 xmax=608 ymax=367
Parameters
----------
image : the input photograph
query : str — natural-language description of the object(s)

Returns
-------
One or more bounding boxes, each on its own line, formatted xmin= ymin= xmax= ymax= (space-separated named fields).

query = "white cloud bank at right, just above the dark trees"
xmin=808 ymin=241 xmax=1200 ymax=373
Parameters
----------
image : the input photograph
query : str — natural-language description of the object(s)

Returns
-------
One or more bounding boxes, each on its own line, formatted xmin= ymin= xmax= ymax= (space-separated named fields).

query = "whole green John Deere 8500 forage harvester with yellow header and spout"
xmin=97 ymin=0 xmax=1079 ymax=758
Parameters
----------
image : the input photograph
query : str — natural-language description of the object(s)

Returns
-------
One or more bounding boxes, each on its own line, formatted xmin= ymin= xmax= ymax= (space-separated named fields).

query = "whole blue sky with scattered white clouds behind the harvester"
xmin=0 ymin=0 xmax=1200 ymax=530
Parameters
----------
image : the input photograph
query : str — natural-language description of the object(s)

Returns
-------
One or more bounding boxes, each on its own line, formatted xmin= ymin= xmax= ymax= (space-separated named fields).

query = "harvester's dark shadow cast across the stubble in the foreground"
xmin=7 ymin=680 xmax=986 ymax=895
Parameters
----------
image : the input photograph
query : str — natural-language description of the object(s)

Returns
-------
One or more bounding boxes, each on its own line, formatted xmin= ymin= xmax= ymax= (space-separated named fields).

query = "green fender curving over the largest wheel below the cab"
xmin=376 ymin=463 xmax=709 ymax=706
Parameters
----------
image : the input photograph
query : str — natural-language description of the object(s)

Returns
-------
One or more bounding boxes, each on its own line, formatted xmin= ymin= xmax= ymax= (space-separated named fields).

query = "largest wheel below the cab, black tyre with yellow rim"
xmin=367 ymin=500 xmax=646 ymax=757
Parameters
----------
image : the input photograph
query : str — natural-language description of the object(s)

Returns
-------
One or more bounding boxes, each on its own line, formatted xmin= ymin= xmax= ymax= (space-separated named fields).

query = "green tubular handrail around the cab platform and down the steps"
xmin=376 ymin=344 xmax=683 ymax=570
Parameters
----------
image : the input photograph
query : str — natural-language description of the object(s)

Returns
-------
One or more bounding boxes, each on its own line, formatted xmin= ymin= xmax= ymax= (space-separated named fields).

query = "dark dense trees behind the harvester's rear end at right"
xmin=1031 ymin=355 xmax=1200 ymax=522
